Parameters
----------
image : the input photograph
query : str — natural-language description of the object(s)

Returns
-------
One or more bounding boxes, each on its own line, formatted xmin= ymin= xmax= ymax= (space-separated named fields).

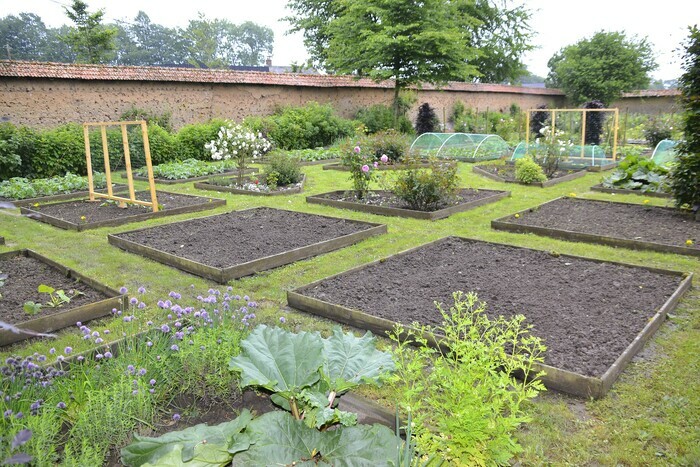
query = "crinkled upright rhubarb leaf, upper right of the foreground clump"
xmin=323 ymin=327 xmax=394 ymax=393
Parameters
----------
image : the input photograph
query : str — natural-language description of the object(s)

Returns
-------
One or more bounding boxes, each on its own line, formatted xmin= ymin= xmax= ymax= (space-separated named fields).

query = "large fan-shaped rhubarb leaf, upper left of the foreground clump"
xmin=229 ymin=325 xmax=323 ymax=399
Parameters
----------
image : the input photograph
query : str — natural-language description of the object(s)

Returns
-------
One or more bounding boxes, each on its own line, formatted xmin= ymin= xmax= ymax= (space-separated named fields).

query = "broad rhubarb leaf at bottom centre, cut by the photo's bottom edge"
xmin=233 ymin=412 xmax=401 ymax=467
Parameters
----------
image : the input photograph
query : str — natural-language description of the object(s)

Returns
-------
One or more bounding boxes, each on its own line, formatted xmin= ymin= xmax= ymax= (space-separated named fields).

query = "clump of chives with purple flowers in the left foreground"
xmin=0 ymin=288 xmax=257 ymax=465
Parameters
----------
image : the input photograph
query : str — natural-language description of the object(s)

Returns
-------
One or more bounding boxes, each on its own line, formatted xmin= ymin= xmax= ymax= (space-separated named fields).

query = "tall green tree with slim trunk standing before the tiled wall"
xmin=326 ymin=0 xmax=477 ymax=118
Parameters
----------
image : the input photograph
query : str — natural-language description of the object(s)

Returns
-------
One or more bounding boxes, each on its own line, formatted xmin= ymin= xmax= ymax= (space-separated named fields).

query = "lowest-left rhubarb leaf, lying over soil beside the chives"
xmin=121 ymin=410 xmax=253 ymax=467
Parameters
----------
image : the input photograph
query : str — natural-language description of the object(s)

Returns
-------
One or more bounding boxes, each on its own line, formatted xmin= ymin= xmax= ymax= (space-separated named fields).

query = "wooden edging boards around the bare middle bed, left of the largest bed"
xmin=107 ymin=208 xmax=387 ymax=284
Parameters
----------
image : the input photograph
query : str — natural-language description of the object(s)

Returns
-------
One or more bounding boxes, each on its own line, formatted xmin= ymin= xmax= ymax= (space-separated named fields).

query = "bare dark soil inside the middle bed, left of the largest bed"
xmin=116 ymin=208 xmax=380 ymax=268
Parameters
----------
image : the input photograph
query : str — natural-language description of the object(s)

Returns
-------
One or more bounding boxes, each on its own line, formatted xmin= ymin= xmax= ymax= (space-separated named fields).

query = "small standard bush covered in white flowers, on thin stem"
xmin=204 ymin=122 xmax=272 ymax=186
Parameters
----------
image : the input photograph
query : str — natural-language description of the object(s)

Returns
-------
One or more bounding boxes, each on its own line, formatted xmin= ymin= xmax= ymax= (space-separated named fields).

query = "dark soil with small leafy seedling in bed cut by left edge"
xmin=0 ymin=255 xmax=109 ymax=324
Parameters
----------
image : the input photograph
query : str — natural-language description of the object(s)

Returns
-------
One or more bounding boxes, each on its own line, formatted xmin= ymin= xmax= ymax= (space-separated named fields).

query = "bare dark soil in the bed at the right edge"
xmin=508 ymin=198 xmax=700 ymax=249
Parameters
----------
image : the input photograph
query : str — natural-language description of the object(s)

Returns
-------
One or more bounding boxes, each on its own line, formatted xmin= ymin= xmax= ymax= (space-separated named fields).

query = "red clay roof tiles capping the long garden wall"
xmin=0 ymin=60 xmax=563 ymax=96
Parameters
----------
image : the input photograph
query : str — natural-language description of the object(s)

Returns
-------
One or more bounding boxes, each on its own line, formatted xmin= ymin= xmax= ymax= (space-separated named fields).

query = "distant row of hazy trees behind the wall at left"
xmin=0 ymin=8 xmax=274 ymax=68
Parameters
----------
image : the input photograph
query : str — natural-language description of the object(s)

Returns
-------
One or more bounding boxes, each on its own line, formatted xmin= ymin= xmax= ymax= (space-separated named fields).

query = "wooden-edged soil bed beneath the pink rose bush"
xmin=306 ymin=188 xmax=510 ymax=220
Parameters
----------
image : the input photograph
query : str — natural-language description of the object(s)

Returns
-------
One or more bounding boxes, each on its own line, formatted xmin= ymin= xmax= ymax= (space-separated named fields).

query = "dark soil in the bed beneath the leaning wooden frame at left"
xmin=25 ymin=191 xmax=216 ymax=224
